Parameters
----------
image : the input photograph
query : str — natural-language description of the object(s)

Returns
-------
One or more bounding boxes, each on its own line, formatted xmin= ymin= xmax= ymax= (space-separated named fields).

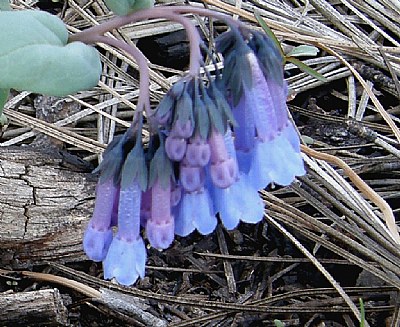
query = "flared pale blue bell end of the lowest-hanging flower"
xmin=103 ymin=234 xmax=146 ymax=286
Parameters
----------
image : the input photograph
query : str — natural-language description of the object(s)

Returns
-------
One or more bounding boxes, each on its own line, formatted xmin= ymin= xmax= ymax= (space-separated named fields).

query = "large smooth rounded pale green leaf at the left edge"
xmin=0 ymin=10 xmax=102 ymax=96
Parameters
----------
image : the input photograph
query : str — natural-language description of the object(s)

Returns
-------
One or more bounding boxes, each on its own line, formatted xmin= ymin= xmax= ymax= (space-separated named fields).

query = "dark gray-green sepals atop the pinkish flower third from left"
xmin=148 ymin=140 xmax=174 ymax=189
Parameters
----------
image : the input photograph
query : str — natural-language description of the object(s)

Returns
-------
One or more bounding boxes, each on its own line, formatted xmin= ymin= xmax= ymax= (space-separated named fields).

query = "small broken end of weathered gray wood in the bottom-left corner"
xmin=0 ymin=289 xmax=69 ymax=327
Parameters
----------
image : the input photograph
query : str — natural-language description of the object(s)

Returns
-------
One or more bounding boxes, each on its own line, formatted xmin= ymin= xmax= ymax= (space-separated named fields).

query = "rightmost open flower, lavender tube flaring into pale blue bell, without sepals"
xmin=244 ymin=55 xmax=305 ymax=188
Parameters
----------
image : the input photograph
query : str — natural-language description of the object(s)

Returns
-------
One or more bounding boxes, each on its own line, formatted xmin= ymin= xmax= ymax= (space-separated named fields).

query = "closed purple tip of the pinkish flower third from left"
xmin=146 ymin=216 xmax=175 ymax=249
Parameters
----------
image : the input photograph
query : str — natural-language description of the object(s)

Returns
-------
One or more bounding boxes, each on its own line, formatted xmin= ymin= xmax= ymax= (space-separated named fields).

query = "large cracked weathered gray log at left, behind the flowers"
xmin=0 ymin=147 xmax=96 ymax=268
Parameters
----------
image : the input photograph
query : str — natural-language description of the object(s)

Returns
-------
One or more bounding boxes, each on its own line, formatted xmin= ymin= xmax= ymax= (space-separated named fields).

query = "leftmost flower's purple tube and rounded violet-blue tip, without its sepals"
xmin=83 ymin=178 xmax=118 ymax=261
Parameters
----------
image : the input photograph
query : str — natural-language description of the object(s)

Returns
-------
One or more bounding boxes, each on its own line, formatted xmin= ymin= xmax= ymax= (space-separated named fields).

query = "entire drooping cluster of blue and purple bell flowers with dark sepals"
xmin=84 ymin=27 xmax=305 ymax=285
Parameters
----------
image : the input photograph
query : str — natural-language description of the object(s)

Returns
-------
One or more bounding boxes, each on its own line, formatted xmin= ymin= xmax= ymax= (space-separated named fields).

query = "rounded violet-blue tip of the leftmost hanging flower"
xmin=83 ymin=221 xmax=112 ymax=261
